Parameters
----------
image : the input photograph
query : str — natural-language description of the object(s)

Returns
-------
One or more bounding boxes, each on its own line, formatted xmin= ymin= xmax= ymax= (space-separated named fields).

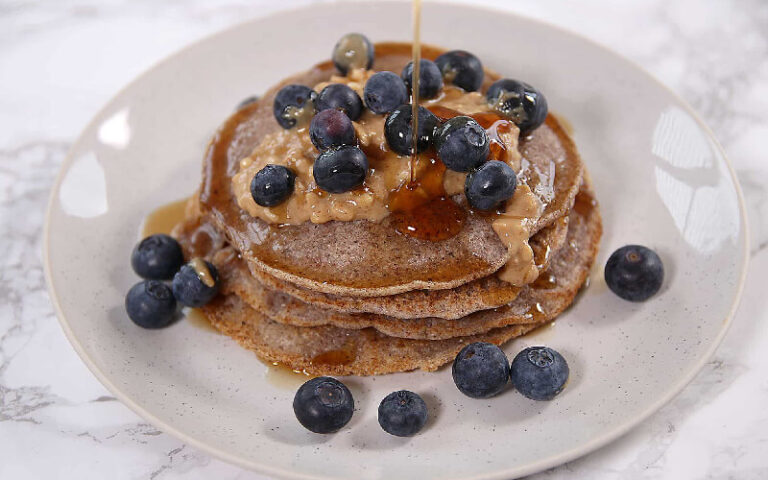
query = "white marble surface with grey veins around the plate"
xmin=0 ymin=0 xmax=768 ymax=480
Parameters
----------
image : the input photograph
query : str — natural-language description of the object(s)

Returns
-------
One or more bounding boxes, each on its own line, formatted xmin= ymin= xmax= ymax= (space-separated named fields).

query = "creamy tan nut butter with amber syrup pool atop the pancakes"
xmin=232 ymin=62 xmax=551 ymax=286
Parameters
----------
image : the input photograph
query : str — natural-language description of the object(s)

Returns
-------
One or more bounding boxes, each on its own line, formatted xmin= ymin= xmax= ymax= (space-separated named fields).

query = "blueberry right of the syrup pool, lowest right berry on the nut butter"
xmin=464 ymin=160 xmax=517 ymax=210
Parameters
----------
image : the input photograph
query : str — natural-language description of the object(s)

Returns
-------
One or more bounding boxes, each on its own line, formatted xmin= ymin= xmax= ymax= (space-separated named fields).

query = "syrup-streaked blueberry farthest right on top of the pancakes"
xmin=485 ymin=78 xmax=547 ymax=133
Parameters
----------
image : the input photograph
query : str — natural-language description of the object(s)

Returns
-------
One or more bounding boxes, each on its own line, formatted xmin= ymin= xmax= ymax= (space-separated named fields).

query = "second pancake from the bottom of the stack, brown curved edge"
xmin=212 ymin=181 xmax=601 ymax=340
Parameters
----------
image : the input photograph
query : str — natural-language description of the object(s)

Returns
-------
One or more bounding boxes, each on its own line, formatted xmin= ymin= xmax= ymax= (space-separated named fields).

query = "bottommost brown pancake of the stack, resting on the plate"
xmin=202 ymin=295 xmax=537 ymax=375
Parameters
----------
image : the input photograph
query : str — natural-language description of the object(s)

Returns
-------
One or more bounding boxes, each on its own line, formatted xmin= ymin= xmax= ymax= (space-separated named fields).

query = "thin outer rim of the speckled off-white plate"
xmin=42 ymin=0 xmax=751 ymax=480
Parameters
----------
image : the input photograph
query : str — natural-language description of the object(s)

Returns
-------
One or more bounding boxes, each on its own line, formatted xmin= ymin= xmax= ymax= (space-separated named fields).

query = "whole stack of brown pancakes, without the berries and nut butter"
xmin=174 ymin=46 xmax=601 ymax=375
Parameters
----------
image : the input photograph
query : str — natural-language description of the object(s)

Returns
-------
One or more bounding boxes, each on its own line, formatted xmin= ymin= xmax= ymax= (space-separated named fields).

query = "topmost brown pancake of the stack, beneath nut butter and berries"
xmin=200 ymin=44 xmax=582 ymax=297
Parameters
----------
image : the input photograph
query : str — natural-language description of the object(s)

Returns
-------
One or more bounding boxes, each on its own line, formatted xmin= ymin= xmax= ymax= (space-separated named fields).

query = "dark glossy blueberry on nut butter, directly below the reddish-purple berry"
xmin=312 ymin=145 xmax=368 ymax=193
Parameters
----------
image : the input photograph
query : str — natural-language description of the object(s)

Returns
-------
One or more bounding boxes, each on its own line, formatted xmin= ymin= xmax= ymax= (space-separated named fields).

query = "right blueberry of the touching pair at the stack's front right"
xmin=510 ymin=347 xmax=568 ymax=400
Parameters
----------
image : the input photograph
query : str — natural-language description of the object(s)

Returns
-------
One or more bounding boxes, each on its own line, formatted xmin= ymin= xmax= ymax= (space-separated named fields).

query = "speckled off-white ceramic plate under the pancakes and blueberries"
xmin=40 ymin=2 xmax=748 ymax=479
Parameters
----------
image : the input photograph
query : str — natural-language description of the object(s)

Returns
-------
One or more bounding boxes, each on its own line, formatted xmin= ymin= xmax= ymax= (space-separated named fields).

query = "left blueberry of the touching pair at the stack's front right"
xmin=451 ymin=342 xmax=509 ymax=398
